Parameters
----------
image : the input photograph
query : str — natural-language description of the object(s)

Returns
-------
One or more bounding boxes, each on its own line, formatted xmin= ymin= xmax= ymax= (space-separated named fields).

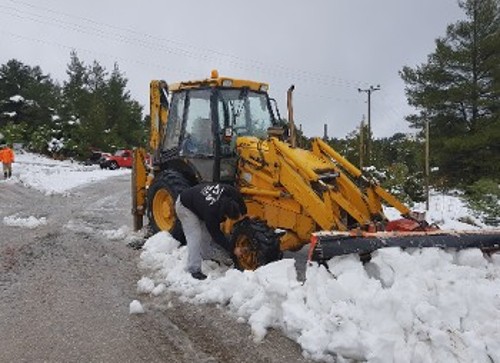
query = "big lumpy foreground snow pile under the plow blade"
xmin=137 ymin=232 xmax=500 ymax=362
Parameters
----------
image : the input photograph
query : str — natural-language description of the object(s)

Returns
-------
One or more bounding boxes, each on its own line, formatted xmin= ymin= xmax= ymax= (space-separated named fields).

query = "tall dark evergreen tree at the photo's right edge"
xmin=400 ymin=0 xmax=500 ymax=185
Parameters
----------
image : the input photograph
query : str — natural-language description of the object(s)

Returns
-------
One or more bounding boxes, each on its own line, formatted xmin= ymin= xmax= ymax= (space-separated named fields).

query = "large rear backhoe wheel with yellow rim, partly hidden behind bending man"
xmin=147 ymin=170 xmax=190 ymax=244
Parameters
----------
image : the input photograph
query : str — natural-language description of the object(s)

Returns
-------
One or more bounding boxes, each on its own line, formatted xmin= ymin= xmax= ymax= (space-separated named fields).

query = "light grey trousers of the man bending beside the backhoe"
xmin=175 ymin=198 xmax=228 ymax=273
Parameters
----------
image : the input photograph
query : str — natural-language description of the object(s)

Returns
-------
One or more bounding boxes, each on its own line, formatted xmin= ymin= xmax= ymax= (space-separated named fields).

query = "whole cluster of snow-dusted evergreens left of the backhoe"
xmin=0 ymin=52 xmax=146 ymax=157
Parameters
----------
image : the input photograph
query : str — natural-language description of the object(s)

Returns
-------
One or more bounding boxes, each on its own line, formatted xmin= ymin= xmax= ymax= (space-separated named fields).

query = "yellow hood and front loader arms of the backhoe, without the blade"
xmin=233 ymin=137 xmax=410 ymax=250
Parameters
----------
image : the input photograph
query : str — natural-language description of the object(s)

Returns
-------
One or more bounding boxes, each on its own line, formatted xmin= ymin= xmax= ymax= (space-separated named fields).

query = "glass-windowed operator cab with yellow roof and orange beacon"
xmin=162 ymin=73 xmax=276 ymax=182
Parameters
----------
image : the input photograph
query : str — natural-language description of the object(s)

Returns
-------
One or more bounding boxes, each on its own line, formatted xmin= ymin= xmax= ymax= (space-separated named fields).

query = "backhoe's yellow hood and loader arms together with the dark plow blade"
xmin=238 ymin=137 xmax=500 ymax=268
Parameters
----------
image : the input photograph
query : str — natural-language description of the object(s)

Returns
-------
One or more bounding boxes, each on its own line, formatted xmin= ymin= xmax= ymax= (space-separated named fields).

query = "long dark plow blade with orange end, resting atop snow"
xmin=308 ymin=230 xmax=500 ymax=262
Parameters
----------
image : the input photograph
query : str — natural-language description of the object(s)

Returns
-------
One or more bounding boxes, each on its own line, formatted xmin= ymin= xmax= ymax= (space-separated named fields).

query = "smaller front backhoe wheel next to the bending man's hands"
xmin=231 ymin=218 xmax=283 ymax=270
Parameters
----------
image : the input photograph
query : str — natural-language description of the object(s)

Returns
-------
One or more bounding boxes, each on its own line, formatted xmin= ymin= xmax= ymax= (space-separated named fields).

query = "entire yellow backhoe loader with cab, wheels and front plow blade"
xmin=132 ymin=71 xmax=500 ymax=269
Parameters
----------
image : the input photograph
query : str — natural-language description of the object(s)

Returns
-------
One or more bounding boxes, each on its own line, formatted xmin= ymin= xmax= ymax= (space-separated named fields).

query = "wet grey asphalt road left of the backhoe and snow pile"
xmin=0 ymin=176 xmax=307 ymax=363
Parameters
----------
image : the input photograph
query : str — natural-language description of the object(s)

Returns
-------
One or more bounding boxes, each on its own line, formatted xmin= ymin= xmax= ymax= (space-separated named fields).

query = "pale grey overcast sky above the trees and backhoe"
xmin=0 ymin=0 xmax=464 ymax=137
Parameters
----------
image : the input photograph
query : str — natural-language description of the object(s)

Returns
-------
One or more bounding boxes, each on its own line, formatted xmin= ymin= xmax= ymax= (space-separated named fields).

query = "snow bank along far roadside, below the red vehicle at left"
xmin=5 ymin=152 xmax=130 ymax=195
